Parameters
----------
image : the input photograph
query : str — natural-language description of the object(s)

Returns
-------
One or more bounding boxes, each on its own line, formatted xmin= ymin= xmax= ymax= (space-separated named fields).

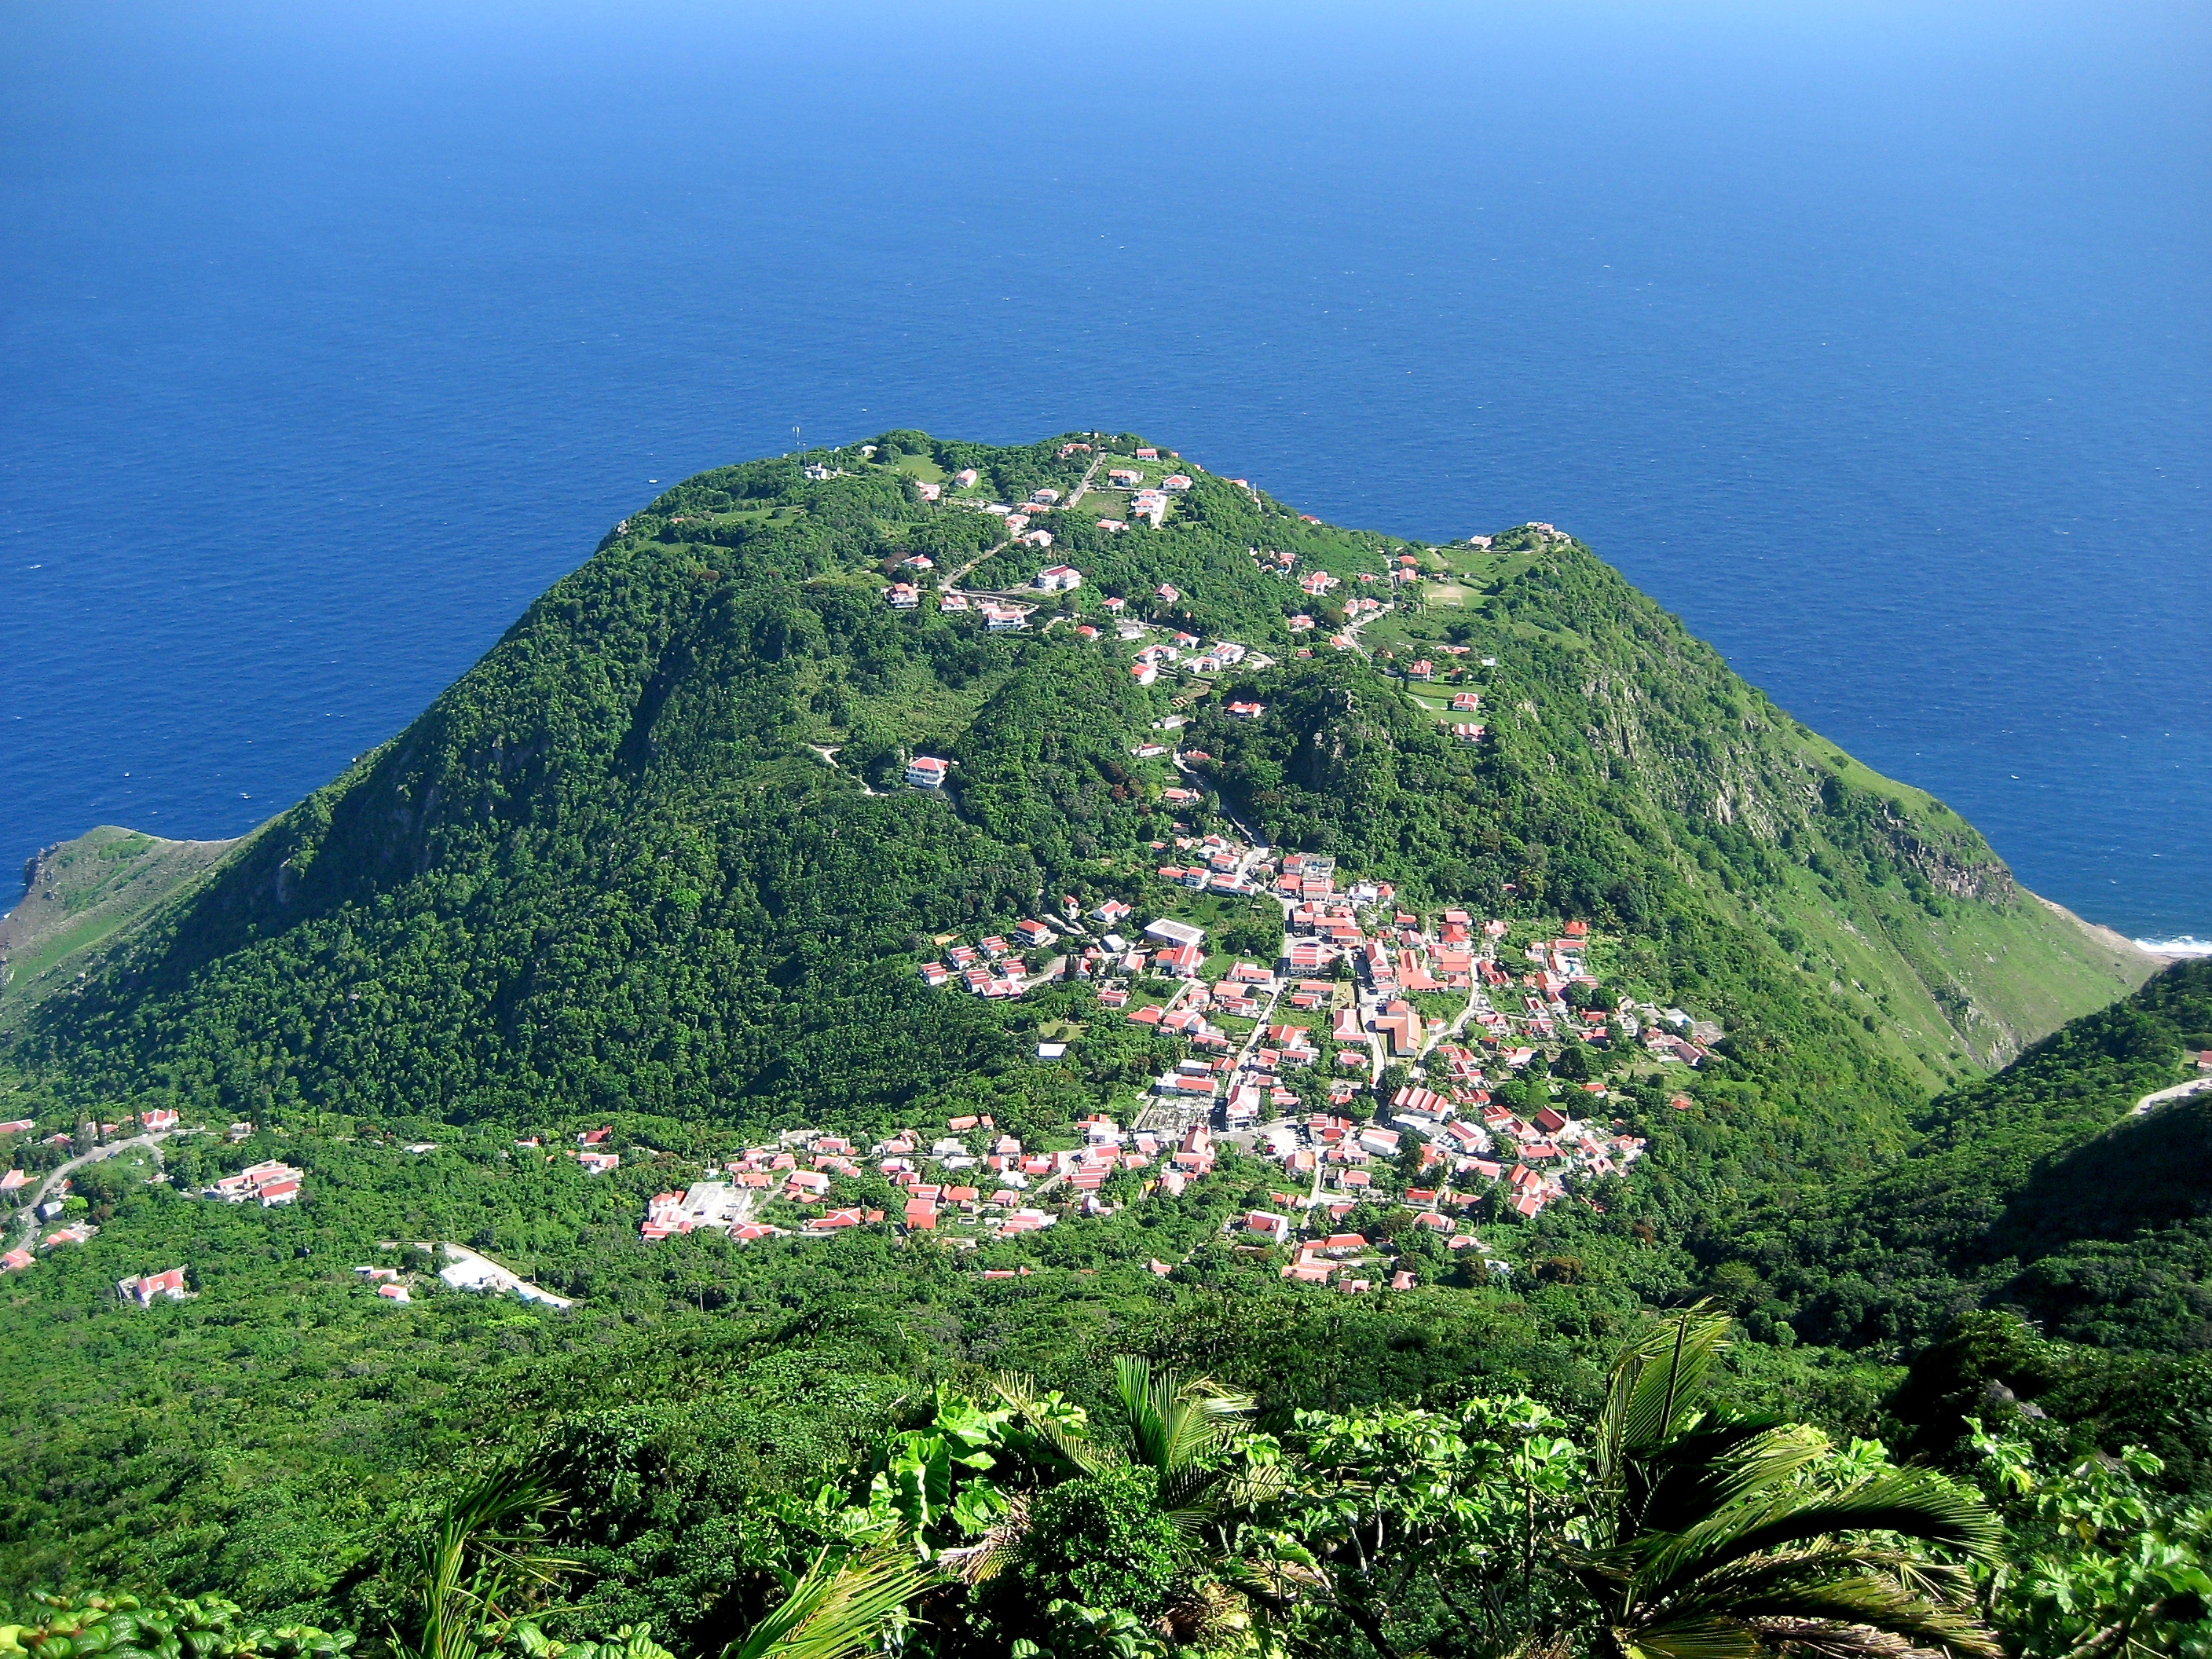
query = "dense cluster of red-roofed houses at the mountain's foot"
xmin=614 ymin=800 xmax=1719 ymax=1290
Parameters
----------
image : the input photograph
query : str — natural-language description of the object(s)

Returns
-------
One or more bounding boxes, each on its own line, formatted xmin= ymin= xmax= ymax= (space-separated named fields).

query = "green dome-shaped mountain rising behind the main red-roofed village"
xmin=0 ymin=434 xmax=2150 ymax=1141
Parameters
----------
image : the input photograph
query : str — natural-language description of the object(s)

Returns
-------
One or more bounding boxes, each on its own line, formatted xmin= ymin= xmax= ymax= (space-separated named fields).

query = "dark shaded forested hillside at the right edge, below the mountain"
xmin=1737 ymin=960 xmax=2212 ymax=1353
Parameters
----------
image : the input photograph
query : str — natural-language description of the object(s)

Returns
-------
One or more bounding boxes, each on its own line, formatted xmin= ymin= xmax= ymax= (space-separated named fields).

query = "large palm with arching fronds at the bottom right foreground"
xmin=1564 ymin=1303 xmax=2004 ymax=1659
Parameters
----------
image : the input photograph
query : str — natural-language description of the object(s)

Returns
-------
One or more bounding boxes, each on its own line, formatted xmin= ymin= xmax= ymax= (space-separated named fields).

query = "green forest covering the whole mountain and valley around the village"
xmin=0 ymin=431 xmax=2212 ymax=1659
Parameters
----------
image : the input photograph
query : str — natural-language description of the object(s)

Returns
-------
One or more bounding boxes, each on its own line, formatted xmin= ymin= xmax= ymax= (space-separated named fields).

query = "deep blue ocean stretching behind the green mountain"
xmin=0 ymin=0 xmax=2212 ymax=938
